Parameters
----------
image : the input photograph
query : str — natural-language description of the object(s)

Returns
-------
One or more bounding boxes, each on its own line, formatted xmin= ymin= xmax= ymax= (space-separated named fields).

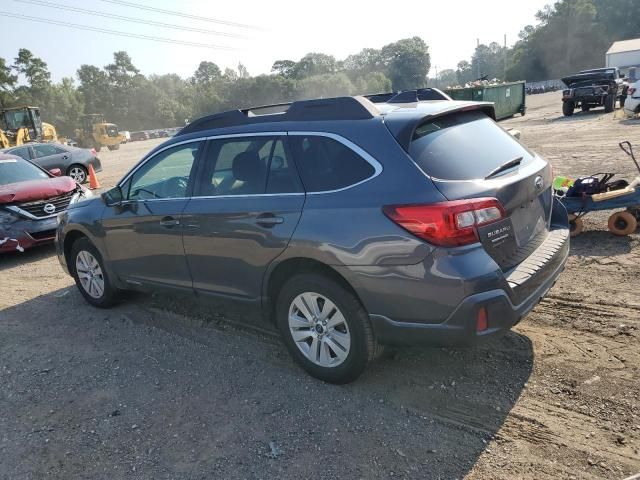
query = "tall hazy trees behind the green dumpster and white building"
xmin=431 ymin=0 xmax=640 ymax=87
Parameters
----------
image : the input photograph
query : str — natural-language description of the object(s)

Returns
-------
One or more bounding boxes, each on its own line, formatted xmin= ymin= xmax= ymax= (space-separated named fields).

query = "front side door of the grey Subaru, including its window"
xmin=102 ymin=141 xmax=204 ymax=289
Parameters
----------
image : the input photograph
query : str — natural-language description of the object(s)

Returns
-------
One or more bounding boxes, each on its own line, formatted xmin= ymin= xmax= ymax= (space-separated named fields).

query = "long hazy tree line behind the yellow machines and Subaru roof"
xmin=0 ymin=37 xmax=430 ymax=136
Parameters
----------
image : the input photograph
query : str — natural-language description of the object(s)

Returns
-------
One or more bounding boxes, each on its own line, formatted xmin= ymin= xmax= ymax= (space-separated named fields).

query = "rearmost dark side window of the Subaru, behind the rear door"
xmin=289 ymin=135 xmax=375 ymax=192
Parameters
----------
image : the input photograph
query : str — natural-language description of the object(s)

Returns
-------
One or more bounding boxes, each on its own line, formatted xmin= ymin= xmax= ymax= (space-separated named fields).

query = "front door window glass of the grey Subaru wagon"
xmin=126 ymin=142 xmax=203 ymax=200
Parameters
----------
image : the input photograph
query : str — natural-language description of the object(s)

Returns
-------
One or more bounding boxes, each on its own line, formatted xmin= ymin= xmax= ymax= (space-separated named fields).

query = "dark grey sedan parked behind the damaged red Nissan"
xmin=0 ymin=143 xmax=102 ymax=184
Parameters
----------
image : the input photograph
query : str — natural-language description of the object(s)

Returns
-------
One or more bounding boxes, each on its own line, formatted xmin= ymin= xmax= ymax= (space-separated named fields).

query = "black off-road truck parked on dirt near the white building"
xmin=562 ymin=68 xmax=628 ymax=117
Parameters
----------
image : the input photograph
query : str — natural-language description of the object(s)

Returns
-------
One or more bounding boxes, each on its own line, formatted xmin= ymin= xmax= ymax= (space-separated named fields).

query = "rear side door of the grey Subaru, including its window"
xmin=183 ymin=133 xmax=305 ymax=301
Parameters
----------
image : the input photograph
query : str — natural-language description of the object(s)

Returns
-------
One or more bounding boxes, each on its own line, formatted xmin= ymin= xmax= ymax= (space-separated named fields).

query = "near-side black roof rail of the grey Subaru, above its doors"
xmin=176 ymin=96 xmax=380 ymax=135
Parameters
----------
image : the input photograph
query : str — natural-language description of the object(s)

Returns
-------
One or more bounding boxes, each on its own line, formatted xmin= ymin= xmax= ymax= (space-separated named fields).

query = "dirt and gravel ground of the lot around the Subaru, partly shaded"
xmin=0 ymin=92 xmax=640 ymax=479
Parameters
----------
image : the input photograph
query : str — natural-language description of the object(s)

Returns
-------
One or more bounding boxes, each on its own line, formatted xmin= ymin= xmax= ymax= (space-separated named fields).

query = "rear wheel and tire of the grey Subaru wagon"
xmin=276 ymin=273 xmax=377 ymax=384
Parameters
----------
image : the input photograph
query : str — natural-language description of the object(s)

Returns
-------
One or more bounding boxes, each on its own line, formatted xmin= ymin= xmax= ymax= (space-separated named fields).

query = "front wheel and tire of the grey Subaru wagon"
xmin=69 ymin=237 xmax=120 ymax=308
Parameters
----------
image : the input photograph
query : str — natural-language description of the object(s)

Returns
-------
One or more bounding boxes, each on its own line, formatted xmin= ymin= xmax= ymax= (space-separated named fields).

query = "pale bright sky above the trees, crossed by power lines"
xmin=0 ymin=0 xmax=552 ymax=81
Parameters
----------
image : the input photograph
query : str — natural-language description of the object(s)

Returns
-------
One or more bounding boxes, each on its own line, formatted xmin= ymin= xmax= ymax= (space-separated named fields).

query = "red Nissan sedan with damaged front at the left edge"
xmin=0 ymin=153 xmax=91 ymax=253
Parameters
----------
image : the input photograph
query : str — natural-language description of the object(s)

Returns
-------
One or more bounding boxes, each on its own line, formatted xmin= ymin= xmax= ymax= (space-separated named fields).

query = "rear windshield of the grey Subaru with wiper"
xmin=409 ymin=112 xmax=532 ymax=180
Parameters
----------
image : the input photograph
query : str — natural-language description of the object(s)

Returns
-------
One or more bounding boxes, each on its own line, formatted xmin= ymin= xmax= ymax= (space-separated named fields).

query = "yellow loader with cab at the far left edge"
xmin=0 ymin=106 xmax=58 ymax=148
